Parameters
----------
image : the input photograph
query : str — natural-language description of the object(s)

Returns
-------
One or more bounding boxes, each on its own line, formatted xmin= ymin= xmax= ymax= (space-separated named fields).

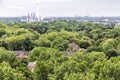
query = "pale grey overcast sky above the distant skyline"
xmin=0 ymin=0 xmax=120 ymax=16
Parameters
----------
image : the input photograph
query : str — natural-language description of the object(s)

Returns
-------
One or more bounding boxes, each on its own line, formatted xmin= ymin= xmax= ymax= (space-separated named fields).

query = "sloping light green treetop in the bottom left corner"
xmin=0 ymin=62 xmax=26 ymax=80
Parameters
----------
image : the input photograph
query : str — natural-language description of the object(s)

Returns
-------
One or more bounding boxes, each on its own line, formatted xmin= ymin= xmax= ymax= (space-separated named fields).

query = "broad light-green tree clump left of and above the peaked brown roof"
xmin=36 ymin=30 xmax=79 ymax=51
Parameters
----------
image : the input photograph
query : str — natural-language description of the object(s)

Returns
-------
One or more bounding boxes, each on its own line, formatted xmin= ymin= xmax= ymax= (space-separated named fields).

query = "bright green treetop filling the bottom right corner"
xmin=93 ymin=57 xmax=120 ymax=80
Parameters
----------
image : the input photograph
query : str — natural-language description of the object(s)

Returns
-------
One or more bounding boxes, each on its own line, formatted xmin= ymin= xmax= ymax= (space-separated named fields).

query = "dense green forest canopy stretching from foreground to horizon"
xmin=0 ymin=21 xmax=120 ymax=80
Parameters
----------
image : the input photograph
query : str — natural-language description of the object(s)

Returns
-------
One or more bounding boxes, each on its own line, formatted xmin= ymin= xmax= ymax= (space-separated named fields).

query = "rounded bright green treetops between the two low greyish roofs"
xmin=29 ymin=47 xmax=62 ymax=61
